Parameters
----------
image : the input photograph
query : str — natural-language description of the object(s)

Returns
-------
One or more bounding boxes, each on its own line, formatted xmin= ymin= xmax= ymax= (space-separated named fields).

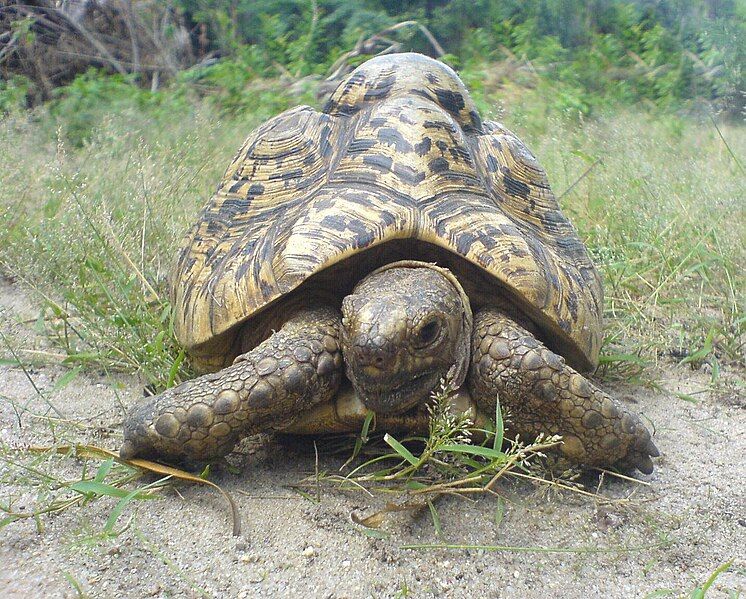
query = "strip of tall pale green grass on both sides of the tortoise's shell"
xmin=0 ymin=72 xmax=746 ymax=389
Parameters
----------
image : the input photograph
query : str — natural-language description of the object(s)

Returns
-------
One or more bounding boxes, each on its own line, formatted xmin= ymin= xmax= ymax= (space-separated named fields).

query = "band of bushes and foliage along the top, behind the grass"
xmin=0 ymin=0 xmax=746 ymax=132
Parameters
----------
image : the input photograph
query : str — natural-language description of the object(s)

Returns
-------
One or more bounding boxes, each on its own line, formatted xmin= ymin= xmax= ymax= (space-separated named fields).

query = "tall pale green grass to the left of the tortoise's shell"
xmin=0 ymin=99 xmax=270 ymax=388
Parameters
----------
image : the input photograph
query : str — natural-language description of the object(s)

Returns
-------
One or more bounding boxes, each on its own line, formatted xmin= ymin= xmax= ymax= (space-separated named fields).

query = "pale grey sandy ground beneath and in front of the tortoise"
xmin=0 ymin=282 xmax=746 ymax=598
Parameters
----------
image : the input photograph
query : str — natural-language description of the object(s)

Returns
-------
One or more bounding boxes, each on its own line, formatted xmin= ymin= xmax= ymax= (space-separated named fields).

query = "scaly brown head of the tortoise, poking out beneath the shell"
xmin=342 ymin=261 xmax=471 ymax=414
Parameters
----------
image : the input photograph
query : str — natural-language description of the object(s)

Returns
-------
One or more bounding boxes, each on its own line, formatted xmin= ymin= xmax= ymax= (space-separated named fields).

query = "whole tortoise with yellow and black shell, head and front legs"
xmin=120 ymin=53 xmax=659 ymax=473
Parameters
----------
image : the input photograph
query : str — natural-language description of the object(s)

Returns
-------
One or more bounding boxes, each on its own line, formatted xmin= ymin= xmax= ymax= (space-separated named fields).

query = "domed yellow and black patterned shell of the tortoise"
xmin=172 ymin=54 xmax=603 ymax=376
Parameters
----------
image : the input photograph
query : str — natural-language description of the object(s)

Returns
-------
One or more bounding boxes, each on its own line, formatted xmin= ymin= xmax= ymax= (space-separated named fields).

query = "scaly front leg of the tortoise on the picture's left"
xmin=119 ymin=308 xmax=342 ymax=462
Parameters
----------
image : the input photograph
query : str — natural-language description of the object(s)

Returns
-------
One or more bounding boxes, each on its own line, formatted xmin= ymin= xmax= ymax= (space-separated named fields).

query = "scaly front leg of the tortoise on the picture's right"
xmin=469 ymin=309 xmax=659 ymax=474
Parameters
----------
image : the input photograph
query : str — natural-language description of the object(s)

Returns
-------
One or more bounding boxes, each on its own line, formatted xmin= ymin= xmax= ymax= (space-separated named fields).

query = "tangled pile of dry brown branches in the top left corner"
xmin=0 ymin=0 xmax=194 ymax=102
